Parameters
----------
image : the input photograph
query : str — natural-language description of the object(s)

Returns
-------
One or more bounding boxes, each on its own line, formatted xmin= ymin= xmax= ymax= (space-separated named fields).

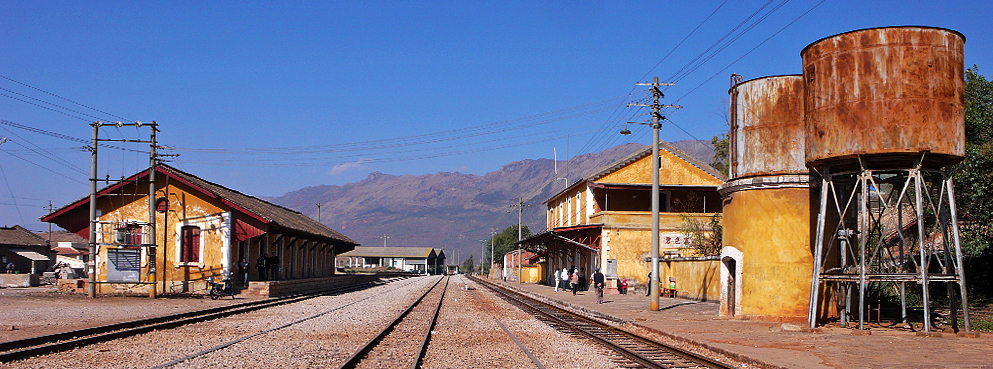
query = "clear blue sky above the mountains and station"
xmin=0 ymin=0 xmax=993 ymax=230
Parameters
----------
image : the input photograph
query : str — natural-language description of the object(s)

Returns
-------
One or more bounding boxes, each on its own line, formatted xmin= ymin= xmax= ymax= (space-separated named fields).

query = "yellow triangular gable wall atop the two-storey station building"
xmin=596 ymin=150 xmax=723 ymax=186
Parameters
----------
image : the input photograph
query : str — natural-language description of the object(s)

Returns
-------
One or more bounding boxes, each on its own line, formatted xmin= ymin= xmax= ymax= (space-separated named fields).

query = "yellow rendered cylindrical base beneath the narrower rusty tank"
xmin=723 ymin=188 xmax=813 ymax=320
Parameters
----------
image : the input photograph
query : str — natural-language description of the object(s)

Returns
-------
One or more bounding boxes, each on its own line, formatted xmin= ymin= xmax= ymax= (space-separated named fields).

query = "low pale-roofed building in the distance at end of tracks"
xmin=335 ymin=246 xmax=445 ymax=275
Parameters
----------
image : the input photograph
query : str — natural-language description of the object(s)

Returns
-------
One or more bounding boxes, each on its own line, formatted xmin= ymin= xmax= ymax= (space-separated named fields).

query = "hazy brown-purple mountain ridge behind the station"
xmin=266 ymin=141 xmax=713 ymax=262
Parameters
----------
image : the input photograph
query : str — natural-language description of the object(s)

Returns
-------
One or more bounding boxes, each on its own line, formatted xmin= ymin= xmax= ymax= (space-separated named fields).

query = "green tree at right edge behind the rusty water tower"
xmin=954 ymin=66 xmax=993 ymax=257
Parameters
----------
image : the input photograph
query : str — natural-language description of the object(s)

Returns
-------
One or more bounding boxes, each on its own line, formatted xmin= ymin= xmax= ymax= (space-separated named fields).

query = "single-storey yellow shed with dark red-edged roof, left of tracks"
xmin=41 ymin=164 xmax=358 ymax=294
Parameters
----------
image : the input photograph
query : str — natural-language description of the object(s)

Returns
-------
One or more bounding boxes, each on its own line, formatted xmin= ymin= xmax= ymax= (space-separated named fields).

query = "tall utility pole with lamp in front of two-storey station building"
xmin=621 ymin=77 xmax=681 ymax=311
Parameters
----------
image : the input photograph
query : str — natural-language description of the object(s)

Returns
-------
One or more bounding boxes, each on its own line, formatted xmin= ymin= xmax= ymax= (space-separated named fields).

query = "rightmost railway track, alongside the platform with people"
xmin=470 ymin=277 xmax=732 ymax=368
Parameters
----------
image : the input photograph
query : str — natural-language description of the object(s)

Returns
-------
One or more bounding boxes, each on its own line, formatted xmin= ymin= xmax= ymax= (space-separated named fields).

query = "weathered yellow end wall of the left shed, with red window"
xmin=97 ymin=176 xmax=234 ymax=294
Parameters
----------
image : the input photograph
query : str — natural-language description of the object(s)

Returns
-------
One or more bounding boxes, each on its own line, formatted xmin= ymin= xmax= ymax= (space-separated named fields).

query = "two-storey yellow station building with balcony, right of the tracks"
xmin=518 ymin=141 xmax=723 ymax=299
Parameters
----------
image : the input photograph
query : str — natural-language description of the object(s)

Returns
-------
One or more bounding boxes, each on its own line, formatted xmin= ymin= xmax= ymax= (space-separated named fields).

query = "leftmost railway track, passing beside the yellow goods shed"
xmin=0 ymin=274 xmax=406 ymax=363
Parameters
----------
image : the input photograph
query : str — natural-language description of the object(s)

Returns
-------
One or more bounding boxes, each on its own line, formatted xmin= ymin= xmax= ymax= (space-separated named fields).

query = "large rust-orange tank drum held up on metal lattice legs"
xmin=800 ymin=27 xmax=965 ymax=168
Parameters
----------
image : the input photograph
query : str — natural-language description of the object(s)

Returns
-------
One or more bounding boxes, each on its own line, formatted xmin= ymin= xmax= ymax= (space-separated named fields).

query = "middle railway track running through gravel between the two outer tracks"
xmin=338 ymin=276 xmax=451 ymax=369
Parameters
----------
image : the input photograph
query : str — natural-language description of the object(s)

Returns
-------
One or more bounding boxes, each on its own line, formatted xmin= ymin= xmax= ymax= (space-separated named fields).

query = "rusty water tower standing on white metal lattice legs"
xmin=800 ymin=27 xmax=970 ymax=332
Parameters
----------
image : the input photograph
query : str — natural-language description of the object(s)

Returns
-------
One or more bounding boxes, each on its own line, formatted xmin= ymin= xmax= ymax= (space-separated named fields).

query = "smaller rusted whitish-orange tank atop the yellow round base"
xmin=729 ymin=75 xmax=807 ymax=179
